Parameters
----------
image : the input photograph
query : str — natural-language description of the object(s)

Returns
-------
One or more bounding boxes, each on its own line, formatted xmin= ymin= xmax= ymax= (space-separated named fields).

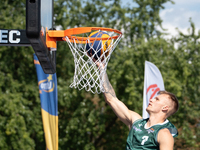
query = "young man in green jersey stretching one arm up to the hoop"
xmin=97 ymin=62 xmax=179 ymax=150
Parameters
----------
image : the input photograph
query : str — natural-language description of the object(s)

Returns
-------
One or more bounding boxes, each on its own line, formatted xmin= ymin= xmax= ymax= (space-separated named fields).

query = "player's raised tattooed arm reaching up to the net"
xmin=103 ymin=73 xmax=141 ymax=129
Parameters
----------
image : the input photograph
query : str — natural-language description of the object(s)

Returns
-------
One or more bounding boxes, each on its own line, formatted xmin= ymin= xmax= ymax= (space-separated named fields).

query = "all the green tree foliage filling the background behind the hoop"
xmin=0 ymin=0 xmax=200 ymax=150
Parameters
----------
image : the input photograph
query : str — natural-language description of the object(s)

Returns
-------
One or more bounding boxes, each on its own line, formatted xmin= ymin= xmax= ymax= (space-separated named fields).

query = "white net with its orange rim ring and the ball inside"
xmin=64 ymin=30 xmax=121 ymax=94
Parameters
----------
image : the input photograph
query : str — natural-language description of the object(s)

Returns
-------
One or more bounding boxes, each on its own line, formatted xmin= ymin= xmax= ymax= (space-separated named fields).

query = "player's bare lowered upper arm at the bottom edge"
xmin=157 ymin=129 xmax=174 ymax=150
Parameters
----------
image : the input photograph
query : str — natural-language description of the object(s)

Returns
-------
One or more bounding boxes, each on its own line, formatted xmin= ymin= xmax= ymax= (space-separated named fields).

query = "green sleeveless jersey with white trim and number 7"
xmin=126 ymin=119 xmax=178 ymax=150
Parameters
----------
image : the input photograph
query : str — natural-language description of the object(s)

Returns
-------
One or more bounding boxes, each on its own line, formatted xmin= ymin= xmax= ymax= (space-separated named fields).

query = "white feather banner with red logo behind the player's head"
xmin=142 ymin=61 xmax=165 ymax=119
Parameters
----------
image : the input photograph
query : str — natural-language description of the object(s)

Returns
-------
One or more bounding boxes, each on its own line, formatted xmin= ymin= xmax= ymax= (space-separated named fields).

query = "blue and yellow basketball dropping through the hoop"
xmin=86 ymin=31 xmax=111 ymax=59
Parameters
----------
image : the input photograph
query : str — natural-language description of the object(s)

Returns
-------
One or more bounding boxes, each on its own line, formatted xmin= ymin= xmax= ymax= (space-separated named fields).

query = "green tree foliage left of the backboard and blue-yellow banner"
xmin=0 ymin=0 xmax=45 ymax=150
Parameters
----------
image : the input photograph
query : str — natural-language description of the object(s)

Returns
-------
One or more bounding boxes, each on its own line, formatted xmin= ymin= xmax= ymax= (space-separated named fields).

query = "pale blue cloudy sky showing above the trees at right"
xmin=122 ymin=0 xmax=200 ymax=38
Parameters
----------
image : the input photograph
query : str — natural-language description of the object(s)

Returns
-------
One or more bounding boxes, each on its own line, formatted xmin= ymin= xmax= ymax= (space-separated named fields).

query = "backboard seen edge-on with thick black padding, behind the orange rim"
xmin=26 ymin=0 xmax=56 ymax=74
